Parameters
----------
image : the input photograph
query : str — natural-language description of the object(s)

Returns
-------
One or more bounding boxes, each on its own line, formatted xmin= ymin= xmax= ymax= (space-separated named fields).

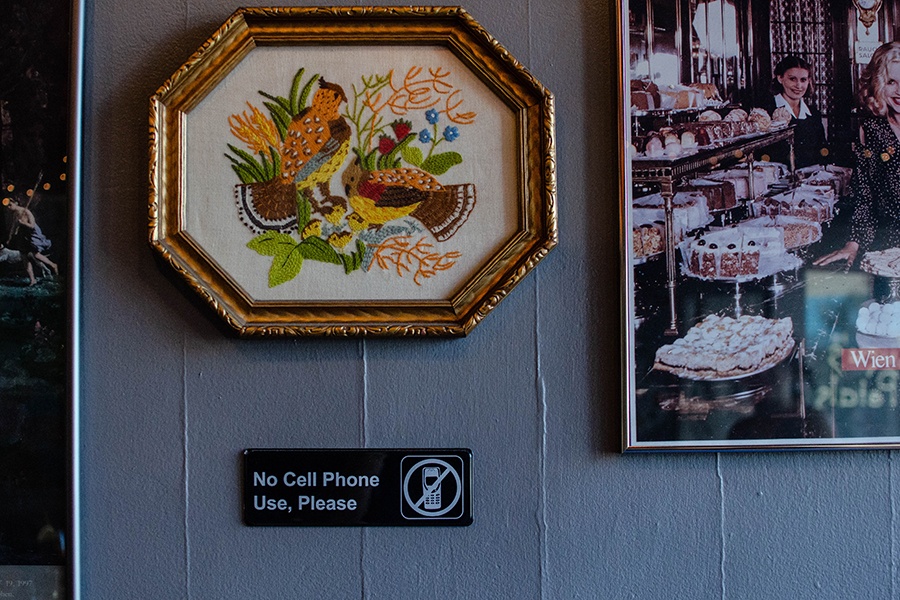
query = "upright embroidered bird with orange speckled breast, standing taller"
xmin=235 ymin=78 xmax=350 ymax=233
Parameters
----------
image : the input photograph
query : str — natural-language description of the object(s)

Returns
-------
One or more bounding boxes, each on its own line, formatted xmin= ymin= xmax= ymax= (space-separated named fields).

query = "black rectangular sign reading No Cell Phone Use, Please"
xmin=243 ymin=448 xmax=472 ymax=527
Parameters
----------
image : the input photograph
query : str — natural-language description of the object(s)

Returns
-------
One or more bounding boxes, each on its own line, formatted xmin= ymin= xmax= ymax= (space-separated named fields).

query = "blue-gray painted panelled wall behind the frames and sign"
xmin=81 ymin=0 xmax=900 ymax=600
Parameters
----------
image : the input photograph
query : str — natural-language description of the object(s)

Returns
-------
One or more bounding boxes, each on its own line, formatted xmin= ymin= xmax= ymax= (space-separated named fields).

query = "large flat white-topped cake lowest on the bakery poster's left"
xmin=653 ymin=315 xmax=794 ymax=379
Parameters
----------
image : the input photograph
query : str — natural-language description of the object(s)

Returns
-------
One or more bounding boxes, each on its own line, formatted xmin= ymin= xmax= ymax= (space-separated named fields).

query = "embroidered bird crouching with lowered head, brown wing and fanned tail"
xmin=341 ymin=157 xmax=475 ymax=242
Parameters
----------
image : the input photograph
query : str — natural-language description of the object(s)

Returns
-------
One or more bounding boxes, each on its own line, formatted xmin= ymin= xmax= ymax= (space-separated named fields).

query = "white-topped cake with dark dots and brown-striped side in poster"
xmin=685 ymin=225 xmax=787 ymax=279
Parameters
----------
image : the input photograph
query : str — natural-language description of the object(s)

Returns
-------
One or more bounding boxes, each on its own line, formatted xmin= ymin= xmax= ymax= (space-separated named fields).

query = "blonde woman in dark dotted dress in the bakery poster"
xmin=815 ymin=42 xmax=900 ymax=265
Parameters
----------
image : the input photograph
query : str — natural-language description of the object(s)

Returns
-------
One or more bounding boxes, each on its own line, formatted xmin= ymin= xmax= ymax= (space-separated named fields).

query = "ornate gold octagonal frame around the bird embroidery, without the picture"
xmin=149 ymin=7 xmax=557 ymax=336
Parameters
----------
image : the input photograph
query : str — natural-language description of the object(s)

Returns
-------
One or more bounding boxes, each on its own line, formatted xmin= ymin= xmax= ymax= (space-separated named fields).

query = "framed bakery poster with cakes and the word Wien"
xmin=618 ymin=0 xmax=900 ymax=450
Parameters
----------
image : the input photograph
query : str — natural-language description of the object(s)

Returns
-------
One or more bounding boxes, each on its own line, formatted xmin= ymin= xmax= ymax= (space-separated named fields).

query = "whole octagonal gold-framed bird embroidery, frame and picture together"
xmin=149 ymin=7 xmax=558 ymax=336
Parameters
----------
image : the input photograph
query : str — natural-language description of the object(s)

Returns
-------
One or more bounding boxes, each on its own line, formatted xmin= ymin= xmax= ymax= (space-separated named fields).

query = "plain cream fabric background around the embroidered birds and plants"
xmin=184 ymin=46 xmax=522 ymax=301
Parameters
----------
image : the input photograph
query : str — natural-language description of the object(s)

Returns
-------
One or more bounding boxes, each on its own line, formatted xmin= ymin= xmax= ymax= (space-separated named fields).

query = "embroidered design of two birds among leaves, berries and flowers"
xmin=225 ymin=67 xmax=476 ymax=287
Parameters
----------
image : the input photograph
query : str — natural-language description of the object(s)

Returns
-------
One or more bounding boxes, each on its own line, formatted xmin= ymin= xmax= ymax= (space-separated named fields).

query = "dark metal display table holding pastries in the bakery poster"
xmin=631 ymin=127 xmax=794 ymax=336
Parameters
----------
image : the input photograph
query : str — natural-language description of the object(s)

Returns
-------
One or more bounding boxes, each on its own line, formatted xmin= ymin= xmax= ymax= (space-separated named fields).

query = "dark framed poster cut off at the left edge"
xmin=0 ymin=0 xmax=83 ymax=600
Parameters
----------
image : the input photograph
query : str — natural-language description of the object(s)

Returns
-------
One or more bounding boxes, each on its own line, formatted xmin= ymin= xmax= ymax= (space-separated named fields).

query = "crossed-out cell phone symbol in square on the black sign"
xmin=400 ymin=456 xmax=464 ymax=519
